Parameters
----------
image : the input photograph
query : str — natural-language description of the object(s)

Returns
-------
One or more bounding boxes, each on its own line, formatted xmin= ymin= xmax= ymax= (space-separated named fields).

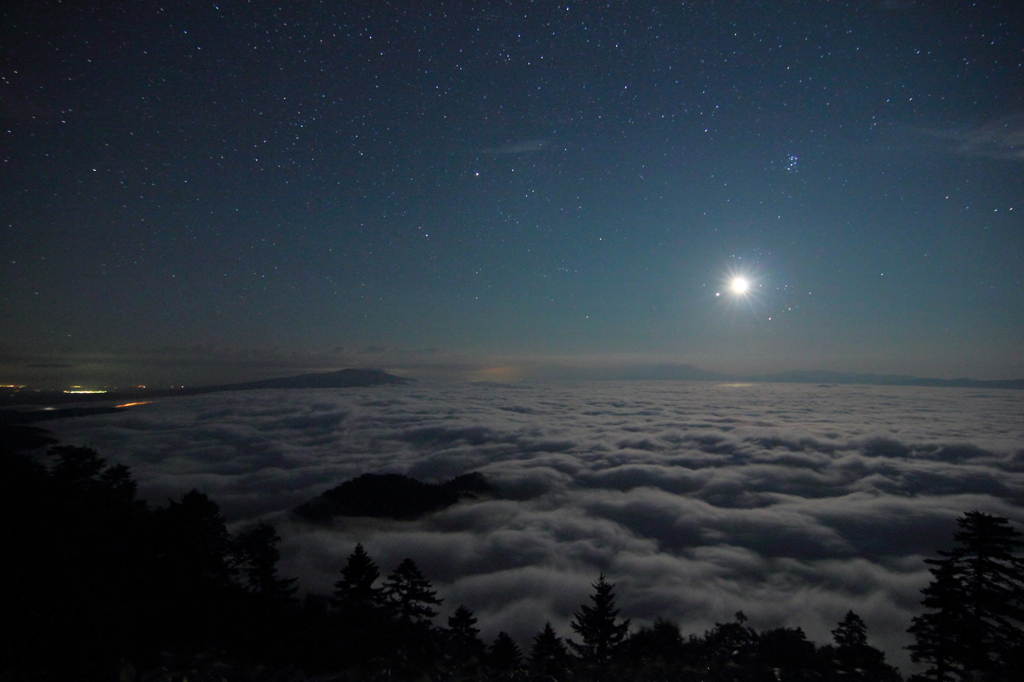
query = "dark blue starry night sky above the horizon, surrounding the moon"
xmin=0 ymin=0 xmax=1024 ymax=382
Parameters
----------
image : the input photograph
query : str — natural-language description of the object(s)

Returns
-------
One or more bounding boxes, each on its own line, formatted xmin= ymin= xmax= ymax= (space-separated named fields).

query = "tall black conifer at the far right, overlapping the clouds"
xmin=907 ymin=511 xmax=1024 ymax=680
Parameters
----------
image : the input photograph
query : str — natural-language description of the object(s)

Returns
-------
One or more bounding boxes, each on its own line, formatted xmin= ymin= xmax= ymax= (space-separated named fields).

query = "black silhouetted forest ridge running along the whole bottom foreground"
xmin=0 ymin=438 xmax=1024 ymax=682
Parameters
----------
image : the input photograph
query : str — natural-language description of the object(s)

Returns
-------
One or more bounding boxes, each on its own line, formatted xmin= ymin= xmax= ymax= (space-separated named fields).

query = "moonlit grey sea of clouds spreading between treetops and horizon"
xmin=46 ymin=381 xmax=1024 ymax=672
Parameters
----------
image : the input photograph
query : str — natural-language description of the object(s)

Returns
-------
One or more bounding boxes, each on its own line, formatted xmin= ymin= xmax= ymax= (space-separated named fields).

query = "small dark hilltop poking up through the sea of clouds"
xmin=295 ymin=472 xmax=492 ymax=521
